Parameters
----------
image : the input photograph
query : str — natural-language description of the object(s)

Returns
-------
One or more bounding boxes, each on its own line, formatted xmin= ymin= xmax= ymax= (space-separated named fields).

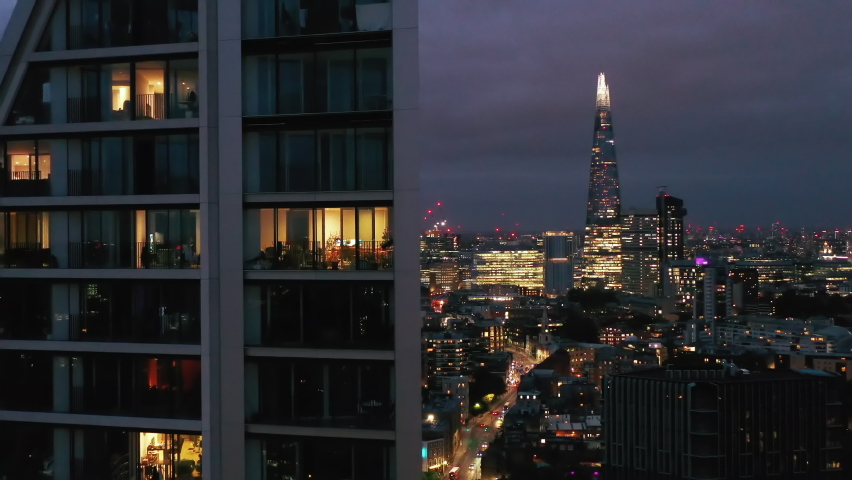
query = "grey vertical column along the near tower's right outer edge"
xmin=391 ymin=0 xmax=421 ymax=480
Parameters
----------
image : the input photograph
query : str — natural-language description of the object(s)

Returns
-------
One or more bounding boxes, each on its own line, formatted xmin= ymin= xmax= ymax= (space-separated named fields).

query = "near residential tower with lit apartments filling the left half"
xmin=0 ymin=0 xmax=421 ymax=480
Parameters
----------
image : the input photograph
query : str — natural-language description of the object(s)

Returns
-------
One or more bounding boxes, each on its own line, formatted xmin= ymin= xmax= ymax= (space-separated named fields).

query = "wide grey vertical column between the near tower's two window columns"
xmin=199 ymin=0 xmax=246 ymax=480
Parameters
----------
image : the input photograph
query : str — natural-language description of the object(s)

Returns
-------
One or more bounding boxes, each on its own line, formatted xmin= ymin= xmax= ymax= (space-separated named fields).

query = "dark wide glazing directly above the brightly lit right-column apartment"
xmin=243 ymin=128 xmax=392 ymax=193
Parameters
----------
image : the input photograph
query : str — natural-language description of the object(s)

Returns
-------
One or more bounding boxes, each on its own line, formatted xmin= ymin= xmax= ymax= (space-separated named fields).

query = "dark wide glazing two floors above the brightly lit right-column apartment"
xmin=243 ymin=48 xmax=393 ymax=116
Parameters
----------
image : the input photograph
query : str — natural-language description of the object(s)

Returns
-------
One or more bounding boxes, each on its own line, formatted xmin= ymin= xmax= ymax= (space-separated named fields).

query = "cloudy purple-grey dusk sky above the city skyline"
xmin=0 ymin=0 xmax=852 ymax=231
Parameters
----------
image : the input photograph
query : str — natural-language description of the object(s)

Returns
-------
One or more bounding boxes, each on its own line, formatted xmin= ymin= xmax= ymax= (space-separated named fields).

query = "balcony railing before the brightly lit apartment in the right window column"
xmin=245 ymin=241 xmax=393 ymax=270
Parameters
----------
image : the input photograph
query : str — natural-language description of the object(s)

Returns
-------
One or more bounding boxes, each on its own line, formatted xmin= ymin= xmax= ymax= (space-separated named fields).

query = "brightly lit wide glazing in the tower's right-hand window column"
xmin=244 ymin=207 xmax=393 ymax=270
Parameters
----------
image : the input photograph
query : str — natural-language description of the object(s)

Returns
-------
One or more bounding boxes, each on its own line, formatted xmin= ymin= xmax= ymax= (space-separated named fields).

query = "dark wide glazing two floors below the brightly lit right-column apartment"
xmin=246 ymin=358 xmax=394 ymax=430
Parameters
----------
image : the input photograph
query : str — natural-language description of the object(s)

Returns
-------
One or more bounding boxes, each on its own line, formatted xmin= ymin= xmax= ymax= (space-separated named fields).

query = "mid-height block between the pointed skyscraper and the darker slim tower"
xmin=621 ymin=209 xmax=660 ymax=296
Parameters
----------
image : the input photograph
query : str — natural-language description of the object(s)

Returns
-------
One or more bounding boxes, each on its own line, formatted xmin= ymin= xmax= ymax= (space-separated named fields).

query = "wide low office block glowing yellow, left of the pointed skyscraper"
xmin=473 ymin=250 xmax=544 ymax=294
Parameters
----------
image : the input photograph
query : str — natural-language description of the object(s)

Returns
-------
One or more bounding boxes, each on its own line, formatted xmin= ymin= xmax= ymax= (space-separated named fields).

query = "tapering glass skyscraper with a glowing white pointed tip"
xmin=583 ymin=73 xmax=621 ymax=289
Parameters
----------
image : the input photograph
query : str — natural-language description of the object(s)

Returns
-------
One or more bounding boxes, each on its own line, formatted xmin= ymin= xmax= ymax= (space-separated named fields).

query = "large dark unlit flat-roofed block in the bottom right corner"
xmin=602 ymin=364 xmax=849 ymax=480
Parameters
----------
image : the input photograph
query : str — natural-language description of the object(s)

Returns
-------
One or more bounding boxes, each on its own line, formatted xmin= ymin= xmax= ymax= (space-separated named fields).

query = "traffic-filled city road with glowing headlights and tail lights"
xmin=444 ymin=351 xmax=535 ymax=480
